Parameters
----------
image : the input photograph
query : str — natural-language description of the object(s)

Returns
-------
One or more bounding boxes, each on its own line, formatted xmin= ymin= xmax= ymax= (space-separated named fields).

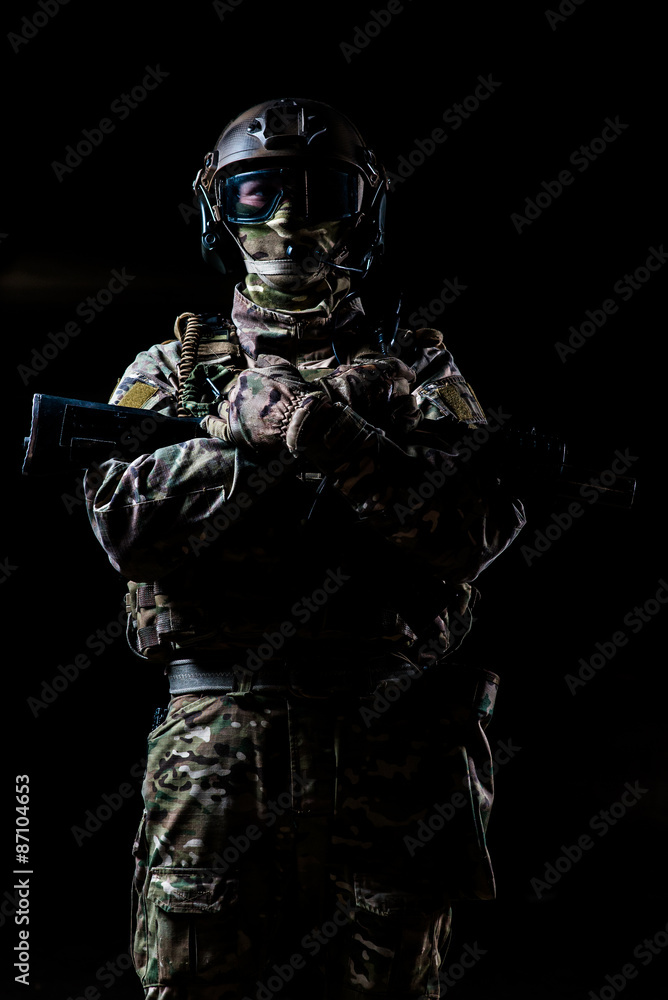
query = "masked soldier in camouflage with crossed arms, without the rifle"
xmin=87 ymin=99 xmax=524 ymax=1000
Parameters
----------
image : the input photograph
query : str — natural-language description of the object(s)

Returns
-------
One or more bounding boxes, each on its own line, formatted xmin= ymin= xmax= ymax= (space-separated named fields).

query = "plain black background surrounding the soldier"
xmin=0 ymin=0 xmax=668 ymax=1000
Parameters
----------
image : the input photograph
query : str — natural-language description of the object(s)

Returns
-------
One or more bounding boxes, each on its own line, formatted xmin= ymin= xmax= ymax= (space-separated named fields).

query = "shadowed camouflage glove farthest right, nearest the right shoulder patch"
xmin=318 ymin=357 xmax=421 ymax=431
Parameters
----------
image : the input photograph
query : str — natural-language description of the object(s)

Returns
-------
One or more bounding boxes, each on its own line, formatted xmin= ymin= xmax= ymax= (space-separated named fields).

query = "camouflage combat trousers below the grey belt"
xmin=134 ymin=670 xmax=497 ymax=1000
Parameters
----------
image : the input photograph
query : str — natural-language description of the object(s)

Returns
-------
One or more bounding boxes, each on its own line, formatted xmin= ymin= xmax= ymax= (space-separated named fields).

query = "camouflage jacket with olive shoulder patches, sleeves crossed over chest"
xmin=86 ymin=289 xmax=524 ymax=665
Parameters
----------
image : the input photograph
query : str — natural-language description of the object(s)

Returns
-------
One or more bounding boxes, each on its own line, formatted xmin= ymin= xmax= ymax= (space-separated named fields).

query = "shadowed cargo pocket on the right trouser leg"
xmin=346 ymin=874 xmax=451 ymax=997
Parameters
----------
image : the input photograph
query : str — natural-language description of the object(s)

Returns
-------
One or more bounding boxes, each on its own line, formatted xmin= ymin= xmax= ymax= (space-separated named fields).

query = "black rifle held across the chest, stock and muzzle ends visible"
xmin=23 ymin=394 xmax=635 ymax=509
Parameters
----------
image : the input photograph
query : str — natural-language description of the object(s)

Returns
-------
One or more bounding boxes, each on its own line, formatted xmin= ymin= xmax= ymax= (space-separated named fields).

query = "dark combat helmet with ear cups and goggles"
xmin=193 ymin=98 xmax=388 ymax=278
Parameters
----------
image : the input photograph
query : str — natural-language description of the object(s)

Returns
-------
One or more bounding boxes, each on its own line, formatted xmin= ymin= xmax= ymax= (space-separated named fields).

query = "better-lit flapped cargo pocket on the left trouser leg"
xmin=142 ymin=867 xmax=238 ymax=986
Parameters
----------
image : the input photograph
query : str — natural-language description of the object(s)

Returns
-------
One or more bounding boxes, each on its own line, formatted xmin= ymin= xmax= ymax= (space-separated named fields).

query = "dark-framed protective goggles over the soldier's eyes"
xmin=216 ymin=167 xmax=361 ymax=225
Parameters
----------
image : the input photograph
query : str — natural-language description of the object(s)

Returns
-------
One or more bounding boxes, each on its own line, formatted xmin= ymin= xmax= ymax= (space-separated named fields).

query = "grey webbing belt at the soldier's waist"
xmin=165 ymin=659 xmax=423 ymax=698
